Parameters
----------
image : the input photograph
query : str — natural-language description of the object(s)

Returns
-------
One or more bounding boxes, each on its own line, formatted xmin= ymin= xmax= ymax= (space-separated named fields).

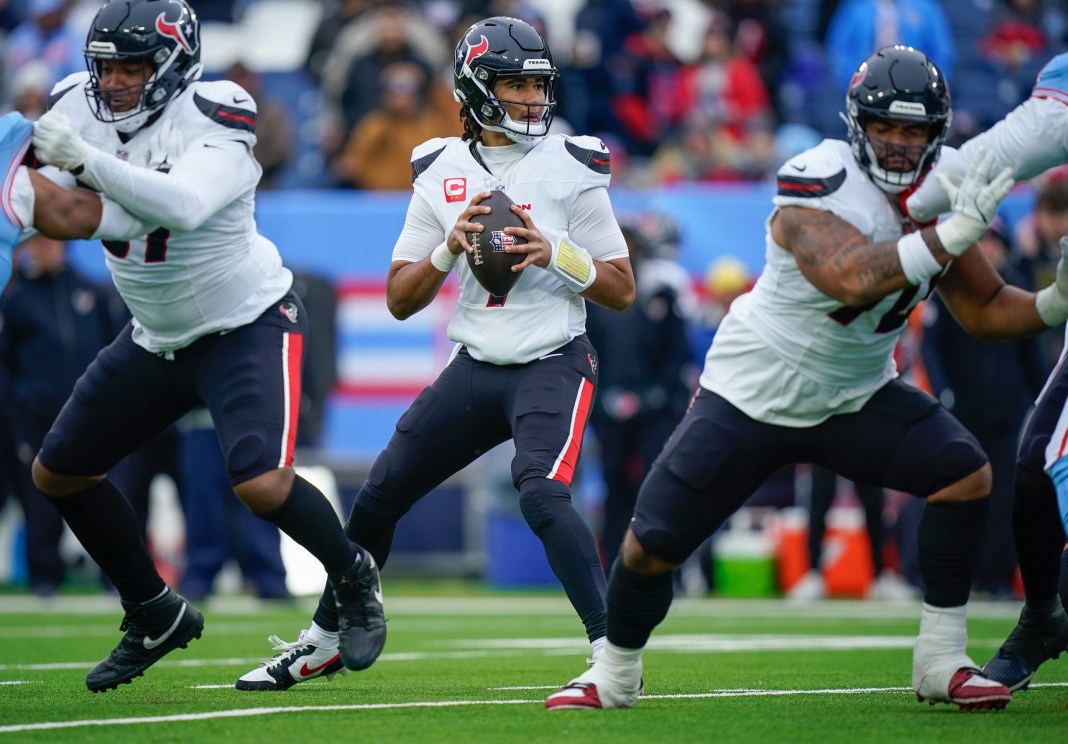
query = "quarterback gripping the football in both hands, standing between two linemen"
xmin=236 ymin=17 xmax=634 ymax=691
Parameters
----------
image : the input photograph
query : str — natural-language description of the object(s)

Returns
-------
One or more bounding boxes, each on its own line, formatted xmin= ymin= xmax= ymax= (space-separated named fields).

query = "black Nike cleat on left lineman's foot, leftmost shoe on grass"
xmin=85 ymin=591 xmax=204 ymax=693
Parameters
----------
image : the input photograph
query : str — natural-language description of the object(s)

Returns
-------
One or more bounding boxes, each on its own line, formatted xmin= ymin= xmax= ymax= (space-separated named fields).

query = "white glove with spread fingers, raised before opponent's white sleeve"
xmin=935 ymin=147 xmax=1016 ymax=256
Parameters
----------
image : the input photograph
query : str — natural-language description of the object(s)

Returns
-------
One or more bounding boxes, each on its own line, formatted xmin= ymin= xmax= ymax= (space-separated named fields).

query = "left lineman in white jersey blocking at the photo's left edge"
xmin=0 ymin=0 xmax=386 ymax=692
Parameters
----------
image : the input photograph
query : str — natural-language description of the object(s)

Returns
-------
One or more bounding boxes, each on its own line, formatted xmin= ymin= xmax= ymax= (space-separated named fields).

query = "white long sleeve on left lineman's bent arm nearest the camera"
xmin=85 ymin=140 xmax=260 ymax=232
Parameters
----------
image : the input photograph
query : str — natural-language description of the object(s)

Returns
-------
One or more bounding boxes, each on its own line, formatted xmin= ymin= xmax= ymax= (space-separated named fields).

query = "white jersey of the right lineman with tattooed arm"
xmin=701 ymin=140 xmax=930 ymax=427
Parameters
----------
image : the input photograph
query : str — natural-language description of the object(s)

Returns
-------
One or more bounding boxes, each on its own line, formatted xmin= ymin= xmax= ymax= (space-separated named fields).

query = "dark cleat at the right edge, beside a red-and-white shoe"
xmin=983 ymin=598 xmax=1068 ymax=692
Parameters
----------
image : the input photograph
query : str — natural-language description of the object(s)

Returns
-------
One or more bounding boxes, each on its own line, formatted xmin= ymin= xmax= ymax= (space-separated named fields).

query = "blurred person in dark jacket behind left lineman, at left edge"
xmin=0 ymin=235 xmax=124 ymax=597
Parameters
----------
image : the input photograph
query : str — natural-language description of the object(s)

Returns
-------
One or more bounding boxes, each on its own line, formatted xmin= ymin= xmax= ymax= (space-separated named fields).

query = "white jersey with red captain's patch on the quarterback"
xmin=393 ymin=134 xmax=628 ymax=364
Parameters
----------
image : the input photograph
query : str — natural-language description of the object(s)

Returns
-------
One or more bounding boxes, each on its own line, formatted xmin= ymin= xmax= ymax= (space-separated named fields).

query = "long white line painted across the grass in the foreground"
xmin=6 ymin=682 xmax=1068 ymax=733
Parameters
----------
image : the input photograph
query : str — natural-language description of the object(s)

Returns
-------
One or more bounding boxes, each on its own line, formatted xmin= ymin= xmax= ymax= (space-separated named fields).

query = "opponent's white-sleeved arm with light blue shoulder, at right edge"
xmin=908 ymin=53 xmax=1068 ymax=222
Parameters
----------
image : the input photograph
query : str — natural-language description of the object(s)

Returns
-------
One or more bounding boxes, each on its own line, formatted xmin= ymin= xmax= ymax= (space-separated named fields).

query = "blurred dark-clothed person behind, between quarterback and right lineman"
xmin=586 ymin=213 xmax=690 ymax=566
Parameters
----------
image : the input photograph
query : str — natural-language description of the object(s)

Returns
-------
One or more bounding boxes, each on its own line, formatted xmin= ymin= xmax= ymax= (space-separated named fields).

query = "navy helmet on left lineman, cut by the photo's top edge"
xmin=84 ymin=0 xmax=201 ymax=133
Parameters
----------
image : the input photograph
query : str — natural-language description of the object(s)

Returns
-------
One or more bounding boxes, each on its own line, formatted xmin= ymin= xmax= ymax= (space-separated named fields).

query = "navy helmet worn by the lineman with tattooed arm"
xmin=843 ymin=46 xmax=953 ymax=193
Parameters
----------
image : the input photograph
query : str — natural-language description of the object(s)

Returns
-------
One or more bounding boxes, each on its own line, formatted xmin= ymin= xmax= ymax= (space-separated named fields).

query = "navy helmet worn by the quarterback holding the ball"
xmin=453 ymin=16 xmax=560 ymax=142
